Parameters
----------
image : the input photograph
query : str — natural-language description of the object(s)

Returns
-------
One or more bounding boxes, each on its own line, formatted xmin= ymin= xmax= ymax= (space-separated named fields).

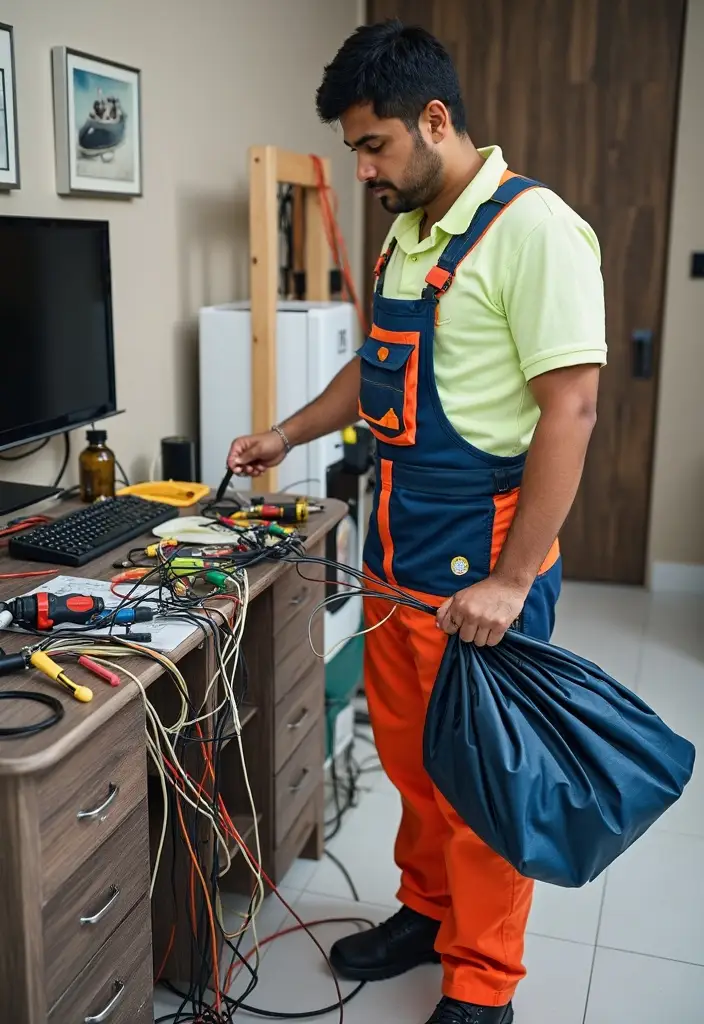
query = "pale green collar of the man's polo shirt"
xmin=393 ymin=145 xmax=507 ymax=253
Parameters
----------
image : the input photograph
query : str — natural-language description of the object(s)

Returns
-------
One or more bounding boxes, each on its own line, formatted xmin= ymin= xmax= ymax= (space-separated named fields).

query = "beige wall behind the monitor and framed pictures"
xmin=0 ymin=0 xmax=362 ymax=491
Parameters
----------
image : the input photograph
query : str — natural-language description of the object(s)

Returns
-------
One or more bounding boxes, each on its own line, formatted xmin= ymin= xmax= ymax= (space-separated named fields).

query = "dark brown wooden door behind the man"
xmin=366 ymin=0 xmax=686 ymax=584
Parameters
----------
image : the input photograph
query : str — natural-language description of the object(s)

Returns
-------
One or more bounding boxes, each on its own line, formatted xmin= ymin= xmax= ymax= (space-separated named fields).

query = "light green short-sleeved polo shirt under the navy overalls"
xmin=384 ymin=146 xmax=607 ymax=456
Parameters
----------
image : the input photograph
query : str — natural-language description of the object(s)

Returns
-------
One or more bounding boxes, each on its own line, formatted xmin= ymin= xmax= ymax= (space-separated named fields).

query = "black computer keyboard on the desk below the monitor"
xmin=9 ymin=495 xmax=178 ymax=565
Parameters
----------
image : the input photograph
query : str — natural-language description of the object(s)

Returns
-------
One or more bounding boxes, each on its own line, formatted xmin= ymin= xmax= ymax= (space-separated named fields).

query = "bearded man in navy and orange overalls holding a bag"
xmin=229 ymin=22 xmax=606 ymax=1024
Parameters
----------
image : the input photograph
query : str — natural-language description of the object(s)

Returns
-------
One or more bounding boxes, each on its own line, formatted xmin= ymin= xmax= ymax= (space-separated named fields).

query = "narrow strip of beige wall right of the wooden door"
xmin=650 ymin=0 xmax=704 ymax=564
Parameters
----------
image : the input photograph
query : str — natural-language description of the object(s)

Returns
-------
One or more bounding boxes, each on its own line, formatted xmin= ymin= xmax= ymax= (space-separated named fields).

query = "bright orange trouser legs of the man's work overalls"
xmin=364 ymin=585 xmax=533 ymax=1007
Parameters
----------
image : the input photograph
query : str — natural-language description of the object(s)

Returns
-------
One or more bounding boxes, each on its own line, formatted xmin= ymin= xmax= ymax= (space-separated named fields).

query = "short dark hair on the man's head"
xmin=316 ymin=18 xmax=467 ymax=135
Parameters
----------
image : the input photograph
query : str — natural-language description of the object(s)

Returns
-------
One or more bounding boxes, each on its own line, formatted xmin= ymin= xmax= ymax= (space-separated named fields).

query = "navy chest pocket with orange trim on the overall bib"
xmin=358 ymin=328 xmax=420 ymax=445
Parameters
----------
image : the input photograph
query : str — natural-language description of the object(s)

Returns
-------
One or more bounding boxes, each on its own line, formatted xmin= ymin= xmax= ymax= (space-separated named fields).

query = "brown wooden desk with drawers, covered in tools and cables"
xmin=0 ymin=501 xmax=346 ymax=1024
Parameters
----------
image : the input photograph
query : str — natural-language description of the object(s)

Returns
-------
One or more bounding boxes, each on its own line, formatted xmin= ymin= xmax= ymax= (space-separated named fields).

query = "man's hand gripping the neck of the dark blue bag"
xmin=437 ymin=577 xmax=528 ymax=647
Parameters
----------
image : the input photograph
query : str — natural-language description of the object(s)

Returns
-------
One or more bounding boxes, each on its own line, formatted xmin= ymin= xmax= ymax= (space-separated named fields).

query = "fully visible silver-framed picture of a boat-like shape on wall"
xmin=51 ymin=46 xmax=142 ymax=197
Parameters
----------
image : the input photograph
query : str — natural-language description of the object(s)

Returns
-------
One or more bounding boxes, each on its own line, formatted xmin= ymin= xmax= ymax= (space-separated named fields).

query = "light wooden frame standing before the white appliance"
xmin=250 ymin=145 xmax=331 ymax=492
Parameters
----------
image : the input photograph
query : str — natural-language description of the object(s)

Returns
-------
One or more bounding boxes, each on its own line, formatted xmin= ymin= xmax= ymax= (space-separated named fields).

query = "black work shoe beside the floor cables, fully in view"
xmin=331 ymin=906 xmax=440 ymax=978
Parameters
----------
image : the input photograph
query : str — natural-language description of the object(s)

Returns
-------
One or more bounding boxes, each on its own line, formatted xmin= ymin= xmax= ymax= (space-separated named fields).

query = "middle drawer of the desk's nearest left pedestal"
xmin=43 ymin=800 xmax=149 ymax=1007
